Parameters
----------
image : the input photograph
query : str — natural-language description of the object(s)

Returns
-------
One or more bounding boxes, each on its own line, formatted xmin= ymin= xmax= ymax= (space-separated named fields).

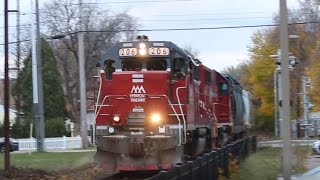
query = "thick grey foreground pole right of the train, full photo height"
xmin=279 ymin=0 xmax=292 ymax=180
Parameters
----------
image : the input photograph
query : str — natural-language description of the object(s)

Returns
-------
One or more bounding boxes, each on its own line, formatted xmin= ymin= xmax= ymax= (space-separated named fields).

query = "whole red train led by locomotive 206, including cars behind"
xmin=95 ymin=36 xmax=250 ymax=171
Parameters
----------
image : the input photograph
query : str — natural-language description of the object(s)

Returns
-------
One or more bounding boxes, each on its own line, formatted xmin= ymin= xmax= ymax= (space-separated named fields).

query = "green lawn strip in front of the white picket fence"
xmin=0 ymin=152 xmax=95 ymax=171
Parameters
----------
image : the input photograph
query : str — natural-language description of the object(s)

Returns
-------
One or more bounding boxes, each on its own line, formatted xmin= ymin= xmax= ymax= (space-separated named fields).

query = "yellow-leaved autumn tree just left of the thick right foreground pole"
xmin=245 ymin=30 xmax=277 ymax=130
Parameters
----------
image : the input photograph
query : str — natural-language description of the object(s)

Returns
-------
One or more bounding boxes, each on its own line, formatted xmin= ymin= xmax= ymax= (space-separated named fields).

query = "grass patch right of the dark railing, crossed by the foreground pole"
xmin=231 ymin=147 xmax=310 ymax=180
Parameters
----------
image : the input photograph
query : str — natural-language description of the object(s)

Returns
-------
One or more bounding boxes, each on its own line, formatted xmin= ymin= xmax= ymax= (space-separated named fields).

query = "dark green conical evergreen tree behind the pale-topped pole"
xmin=12 ymin=40 xmax=66 ymax=137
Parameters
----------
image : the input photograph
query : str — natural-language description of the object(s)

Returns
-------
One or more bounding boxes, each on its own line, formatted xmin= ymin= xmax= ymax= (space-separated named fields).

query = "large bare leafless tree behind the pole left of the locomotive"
xmin=43 ymin=0 xmax=137 ymax=134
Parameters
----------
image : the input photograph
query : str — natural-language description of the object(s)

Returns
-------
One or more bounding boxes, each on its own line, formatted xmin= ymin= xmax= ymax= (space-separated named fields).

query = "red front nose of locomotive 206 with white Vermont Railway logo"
xmin=112 ymin=71 xmax=169 ymax=126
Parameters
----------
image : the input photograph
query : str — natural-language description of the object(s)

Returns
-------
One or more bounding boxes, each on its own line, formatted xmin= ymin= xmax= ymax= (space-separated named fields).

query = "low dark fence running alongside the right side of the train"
xmin=149 ymin=136 xmax=257 ymax=180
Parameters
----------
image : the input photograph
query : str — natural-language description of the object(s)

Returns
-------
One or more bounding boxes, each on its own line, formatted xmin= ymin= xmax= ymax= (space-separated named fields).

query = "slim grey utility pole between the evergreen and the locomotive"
xmin=78 ymin=0 xmax=88 ymax=148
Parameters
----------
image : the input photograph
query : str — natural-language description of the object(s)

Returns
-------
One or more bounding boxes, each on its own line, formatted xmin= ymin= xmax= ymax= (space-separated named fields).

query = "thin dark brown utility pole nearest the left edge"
xmin=3 ymin=0 xmax=10 ymax=173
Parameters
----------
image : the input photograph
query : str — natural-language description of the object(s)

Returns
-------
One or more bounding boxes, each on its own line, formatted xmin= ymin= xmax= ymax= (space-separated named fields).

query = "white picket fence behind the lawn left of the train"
xmin=18 ymin=136 xmax=85 ymax=151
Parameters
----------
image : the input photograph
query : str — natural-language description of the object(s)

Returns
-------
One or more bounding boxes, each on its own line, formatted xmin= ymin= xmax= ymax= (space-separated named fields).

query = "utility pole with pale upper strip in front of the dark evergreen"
xmin=31 ymin=0 xmax=45 ymax=151
